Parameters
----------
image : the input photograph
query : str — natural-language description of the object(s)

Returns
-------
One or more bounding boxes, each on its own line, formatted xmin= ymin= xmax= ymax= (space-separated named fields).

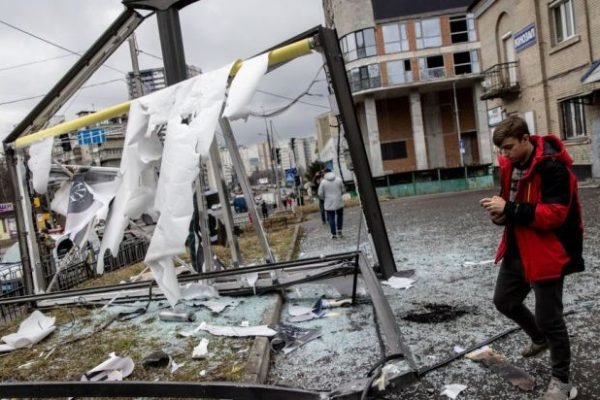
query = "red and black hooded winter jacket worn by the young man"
xmin=496 ymin=135 xmax=584 ymax=282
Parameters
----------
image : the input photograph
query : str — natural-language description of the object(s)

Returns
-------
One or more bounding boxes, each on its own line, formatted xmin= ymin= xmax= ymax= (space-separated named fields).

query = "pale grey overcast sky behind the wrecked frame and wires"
xmin=0 ymin=0 xmax=329 ymax=151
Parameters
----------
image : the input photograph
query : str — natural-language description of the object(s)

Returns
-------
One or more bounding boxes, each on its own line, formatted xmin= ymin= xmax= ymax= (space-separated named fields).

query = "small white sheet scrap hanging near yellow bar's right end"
xmin=223 ymin=53 xmax=269 ymax=121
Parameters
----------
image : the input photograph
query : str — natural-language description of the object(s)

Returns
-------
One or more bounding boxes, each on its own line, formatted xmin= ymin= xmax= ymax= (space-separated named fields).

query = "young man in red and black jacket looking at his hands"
xmin=480 ymin=116 xmax=584 ymax=400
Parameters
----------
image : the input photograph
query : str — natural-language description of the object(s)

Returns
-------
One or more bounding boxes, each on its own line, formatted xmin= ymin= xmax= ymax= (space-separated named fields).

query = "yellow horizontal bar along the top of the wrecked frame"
xmin=14 ymin=38 xmax=312 ymax=149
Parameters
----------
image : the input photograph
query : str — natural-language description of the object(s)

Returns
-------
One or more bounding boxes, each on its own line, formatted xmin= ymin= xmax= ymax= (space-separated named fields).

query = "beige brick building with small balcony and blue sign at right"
xmin=470 ymin=0 xmax=600 ymax=178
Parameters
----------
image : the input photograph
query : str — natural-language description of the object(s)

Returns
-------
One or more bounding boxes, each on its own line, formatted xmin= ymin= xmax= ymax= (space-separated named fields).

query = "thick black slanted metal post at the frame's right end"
xmin=319 ymin=27 xmax=396 ymax=279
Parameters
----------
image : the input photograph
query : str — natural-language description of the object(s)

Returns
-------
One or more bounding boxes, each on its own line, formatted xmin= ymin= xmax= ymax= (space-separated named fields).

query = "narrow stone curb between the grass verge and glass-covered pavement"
xmin=242 ymin=223 xmax=300 ymax=384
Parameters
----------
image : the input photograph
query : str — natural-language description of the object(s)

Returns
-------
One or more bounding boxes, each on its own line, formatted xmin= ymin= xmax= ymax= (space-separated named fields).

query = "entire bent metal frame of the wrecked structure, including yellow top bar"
xmin=0 ymin=0 xmax=418 ymax=400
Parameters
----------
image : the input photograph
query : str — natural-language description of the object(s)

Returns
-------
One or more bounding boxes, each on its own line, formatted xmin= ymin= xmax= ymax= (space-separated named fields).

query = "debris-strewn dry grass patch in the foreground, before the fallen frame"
xmin=0 ymin=308 xmax=252 ymax=382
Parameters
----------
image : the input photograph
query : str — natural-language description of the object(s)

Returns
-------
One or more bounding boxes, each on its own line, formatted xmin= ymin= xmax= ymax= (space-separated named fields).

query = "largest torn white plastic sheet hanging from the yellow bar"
xmin=98 ymin=65 xmax=231 ymax=306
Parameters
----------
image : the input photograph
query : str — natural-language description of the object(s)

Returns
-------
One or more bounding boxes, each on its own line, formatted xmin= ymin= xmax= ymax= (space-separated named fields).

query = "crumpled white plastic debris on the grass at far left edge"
xmin=0 ymin=310 xmax=56 ymax=353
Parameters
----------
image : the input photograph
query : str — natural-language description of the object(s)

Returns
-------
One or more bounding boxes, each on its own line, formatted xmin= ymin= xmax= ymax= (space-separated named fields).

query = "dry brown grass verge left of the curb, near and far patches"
xmin=0 ymin=220 xmax=298 ymax=382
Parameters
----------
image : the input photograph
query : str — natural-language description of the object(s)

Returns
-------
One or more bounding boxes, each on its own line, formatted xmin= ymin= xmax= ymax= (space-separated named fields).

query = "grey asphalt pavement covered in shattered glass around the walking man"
xmin=269 ymin=188 xmax=600 ymax=400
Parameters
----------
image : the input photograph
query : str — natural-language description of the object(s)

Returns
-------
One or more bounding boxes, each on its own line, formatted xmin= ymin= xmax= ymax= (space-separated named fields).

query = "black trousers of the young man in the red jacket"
xmin=494 ymin=258 xmax=571 ymax=382
